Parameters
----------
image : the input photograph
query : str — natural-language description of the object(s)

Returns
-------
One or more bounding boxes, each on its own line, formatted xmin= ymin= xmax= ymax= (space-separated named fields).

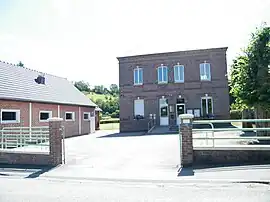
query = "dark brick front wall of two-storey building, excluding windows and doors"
xmin=119 ymin=48 xmax=229 ymax=131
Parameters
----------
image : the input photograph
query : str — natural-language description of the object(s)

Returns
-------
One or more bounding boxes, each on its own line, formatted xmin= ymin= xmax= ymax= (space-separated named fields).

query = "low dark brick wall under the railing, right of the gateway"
xmin=193 ymin=148 xmax=270 ymax=165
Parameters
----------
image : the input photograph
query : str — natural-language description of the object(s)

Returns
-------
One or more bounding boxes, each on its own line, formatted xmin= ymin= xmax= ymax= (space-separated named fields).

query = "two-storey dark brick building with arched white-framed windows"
xmin=117 ymin=47 xmax=229 ymax=132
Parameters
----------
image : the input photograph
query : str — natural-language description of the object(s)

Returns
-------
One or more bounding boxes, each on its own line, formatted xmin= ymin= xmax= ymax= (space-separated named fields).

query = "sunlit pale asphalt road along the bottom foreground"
xmin=0 ymin=177 xmax=270 ymax=202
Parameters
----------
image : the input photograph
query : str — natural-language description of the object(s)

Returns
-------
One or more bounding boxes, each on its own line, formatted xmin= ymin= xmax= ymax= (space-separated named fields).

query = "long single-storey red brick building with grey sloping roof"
xmin=0 ymin=61 xmax=96 ymax=137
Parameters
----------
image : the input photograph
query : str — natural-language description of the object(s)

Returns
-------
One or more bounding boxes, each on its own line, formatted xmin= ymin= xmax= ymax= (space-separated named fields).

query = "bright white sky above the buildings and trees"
xmin=0 ymin=0 xmax=270 ymax=86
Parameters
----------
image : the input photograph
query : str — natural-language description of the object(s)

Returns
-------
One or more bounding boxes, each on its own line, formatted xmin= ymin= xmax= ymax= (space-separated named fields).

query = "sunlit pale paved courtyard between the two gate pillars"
xmin=43 ymin=131 xmax=180 ymax=177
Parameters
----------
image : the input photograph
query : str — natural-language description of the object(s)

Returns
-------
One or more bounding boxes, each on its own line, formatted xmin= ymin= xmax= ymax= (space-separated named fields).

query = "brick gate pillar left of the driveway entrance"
xmin=49 ymin=118 xmax=63 ymax=166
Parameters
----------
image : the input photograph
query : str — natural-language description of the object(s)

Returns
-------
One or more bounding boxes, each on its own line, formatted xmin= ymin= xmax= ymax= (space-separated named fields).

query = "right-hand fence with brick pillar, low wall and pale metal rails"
xmin=179 ymin=114 xmax=270 ymax=166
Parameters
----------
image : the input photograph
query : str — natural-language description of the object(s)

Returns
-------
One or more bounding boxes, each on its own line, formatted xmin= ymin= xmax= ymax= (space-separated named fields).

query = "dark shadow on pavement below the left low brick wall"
xmin=0 ymin=164 xmax=55 ymax=178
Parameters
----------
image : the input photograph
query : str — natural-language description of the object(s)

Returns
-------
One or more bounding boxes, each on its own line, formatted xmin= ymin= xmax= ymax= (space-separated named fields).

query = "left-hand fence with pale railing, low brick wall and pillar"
xmin=0 ymin=118 xmax=65 ymax=166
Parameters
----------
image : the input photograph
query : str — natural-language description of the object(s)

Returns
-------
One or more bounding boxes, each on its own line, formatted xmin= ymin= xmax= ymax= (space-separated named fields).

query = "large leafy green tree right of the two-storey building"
xmin=231 ymin=24 xmax=270 ymax=137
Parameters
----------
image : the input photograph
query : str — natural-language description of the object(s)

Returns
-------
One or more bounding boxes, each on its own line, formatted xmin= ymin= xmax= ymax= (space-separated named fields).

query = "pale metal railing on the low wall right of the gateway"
xmin=192 ymin=119 xmax=270 ymax=147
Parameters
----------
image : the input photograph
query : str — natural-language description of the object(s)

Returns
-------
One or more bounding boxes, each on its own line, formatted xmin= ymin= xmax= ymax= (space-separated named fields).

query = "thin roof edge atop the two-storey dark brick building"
xmin=117 ymin=47 xmax=228 ymax=60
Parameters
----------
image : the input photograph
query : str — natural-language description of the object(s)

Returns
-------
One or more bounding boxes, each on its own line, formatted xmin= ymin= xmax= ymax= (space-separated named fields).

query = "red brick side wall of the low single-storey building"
xmin=0 ymin=100 xmax=94 ymax=137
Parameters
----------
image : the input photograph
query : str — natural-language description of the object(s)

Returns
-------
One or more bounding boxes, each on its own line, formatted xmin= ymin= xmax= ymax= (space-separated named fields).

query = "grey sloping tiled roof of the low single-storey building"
xmin=0 ymin=61 xmax=97 ymax=107
